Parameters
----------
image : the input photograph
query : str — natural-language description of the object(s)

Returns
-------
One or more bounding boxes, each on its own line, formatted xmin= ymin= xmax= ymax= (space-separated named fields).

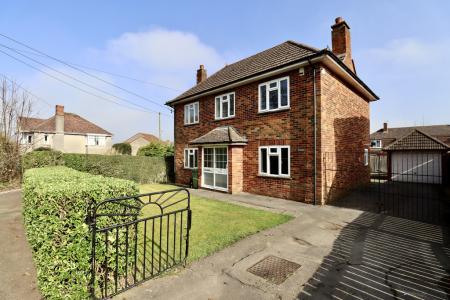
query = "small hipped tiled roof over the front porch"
xmin=189 ymin=126 xmax=247 ymax=145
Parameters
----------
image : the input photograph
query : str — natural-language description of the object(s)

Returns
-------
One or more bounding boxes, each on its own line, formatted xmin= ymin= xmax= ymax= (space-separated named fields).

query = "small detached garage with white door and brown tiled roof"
xmin=384 ymin=130 xmax=449 ymax=184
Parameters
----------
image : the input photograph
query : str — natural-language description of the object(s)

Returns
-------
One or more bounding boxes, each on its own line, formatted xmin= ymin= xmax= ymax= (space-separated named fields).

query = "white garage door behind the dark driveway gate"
xmin=391 ymin=151 xmax=442 ymax=184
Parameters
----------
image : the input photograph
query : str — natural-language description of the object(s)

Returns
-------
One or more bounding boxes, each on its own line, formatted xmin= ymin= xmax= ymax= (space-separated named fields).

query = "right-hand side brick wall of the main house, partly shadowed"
xmin=319 ymin=68 xmax=370 ymax=202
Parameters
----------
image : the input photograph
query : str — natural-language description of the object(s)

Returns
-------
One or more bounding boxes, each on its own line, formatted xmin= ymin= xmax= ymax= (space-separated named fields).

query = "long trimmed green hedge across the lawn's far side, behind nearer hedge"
xmin=23 ymin=151 xmax=173 ymax=183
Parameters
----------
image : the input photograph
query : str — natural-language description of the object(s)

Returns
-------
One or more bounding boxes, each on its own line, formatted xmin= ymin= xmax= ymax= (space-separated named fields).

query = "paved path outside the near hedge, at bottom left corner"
xmin=0 ymin=191 xmax=42 ymax=300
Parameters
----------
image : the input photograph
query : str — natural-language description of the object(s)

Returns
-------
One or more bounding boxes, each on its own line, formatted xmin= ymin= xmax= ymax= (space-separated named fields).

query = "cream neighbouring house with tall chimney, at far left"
xmin=19 ymin=105 xmax=112 ymax=154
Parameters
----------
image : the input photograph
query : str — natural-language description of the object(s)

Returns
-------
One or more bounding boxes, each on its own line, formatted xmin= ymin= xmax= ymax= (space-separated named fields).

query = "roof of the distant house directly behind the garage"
xmin=370 ymin=125 xmax=450 ymax=145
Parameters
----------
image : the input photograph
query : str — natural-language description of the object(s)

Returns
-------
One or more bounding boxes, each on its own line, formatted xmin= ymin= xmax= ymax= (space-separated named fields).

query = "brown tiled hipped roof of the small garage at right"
xmin=384 ymin=129 xmax=449 ymax=151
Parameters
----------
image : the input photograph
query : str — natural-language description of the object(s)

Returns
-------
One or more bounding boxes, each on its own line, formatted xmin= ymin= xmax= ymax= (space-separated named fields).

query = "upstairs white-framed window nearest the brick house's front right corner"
xmin=258 ymin=77 xmax=290 ymax=112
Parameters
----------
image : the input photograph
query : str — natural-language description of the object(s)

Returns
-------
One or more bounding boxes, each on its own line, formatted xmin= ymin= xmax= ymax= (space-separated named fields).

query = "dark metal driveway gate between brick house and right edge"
xmin=323 ymin=152 xmax=450 ymax=226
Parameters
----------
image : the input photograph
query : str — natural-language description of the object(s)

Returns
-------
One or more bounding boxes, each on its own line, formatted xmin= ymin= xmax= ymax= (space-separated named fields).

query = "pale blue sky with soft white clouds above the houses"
xmin=0 ymin=0 xmax=450 ymax=142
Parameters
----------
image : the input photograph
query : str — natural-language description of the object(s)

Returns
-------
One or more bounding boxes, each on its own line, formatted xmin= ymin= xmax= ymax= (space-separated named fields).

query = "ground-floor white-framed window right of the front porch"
xmin=259 ymin=146 xmax=291 ymax=177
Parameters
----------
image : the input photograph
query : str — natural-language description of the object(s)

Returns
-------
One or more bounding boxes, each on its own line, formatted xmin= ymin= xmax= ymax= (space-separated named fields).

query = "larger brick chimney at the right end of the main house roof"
xmin=331 ymin=17 xmax=356 ymax=73
